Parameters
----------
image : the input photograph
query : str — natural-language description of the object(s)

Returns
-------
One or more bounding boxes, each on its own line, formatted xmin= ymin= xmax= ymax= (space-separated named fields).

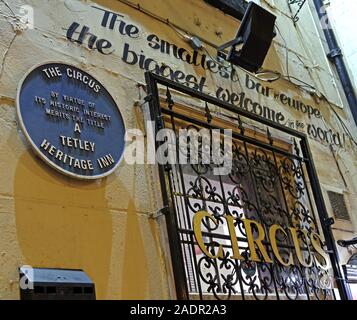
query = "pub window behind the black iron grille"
xmin=161 ymin=95 xmax=332 ymax=299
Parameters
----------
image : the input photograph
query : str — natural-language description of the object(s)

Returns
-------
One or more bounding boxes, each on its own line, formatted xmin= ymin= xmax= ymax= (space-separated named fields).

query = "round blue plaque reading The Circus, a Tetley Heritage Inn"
xmin=16 ymin=63 xmax=125 ymax=179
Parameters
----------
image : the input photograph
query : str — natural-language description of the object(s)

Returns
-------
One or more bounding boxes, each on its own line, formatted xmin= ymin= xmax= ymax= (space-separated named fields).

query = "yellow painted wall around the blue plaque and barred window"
xmin=0 ymin=0 xmax=357 ymax=299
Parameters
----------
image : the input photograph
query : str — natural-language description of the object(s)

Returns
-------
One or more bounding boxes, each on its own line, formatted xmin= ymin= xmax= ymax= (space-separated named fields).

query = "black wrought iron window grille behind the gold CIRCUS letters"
xmin=146 ymin=73 xmax=346 ymax=300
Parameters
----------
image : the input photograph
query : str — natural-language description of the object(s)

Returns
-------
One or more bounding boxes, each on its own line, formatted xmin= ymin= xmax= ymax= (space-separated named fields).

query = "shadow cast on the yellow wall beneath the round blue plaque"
xmin=14 ymin=152 xmax=148 ymax=299
